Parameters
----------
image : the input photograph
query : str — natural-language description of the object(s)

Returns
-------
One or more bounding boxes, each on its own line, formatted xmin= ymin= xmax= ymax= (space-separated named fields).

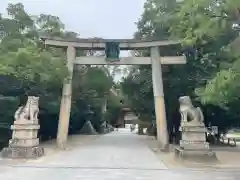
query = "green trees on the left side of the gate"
xmin=0 ymin=3 xmax=120 ymax=145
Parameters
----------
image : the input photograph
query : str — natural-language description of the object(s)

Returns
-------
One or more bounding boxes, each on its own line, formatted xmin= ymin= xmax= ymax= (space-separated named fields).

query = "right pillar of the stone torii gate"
xmin=151 ymin=47 xmax=168 ymax=149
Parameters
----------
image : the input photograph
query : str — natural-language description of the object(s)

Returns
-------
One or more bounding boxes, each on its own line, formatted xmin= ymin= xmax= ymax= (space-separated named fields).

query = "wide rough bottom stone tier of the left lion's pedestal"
xmin=1 ymin=146 xmax=44 ymax=159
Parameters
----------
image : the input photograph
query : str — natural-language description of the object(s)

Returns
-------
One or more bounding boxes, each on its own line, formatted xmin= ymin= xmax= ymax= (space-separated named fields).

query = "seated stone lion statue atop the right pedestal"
xmin=179 ymin=96 xmax=204 ymax=124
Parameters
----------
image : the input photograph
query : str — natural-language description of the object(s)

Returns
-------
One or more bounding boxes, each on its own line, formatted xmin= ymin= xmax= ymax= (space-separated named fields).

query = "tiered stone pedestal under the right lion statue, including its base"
xmin=175 ymin=122 xmax=217 ymax=161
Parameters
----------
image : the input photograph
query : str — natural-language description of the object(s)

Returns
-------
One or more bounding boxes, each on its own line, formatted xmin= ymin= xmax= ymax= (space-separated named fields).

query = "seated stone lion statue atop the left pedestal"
xmin=14 ymin=96 xmax=39 ymax=121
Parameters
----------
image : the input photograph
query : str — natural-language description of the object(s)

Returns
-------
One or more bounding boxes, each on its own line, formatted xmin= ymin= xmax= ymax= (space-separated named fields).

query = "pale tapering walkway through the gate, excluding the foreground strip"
xmin=15 ymin=132 xmax=167 ymax=169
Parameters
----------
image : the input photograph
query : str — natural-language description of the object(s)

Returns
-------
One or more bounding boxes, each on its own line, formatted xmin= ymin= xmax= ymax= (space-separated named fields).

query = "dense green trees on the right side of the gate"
xmin=122 ymin=0 xmax=240 ymax=142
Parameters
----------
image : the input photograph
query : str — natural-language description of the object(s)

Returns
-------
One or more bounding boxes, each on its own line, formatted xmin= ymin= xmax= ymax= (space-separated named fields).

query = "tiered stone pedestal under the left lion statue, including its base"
xmin=2 ymin=120 xmax=44 ymax=158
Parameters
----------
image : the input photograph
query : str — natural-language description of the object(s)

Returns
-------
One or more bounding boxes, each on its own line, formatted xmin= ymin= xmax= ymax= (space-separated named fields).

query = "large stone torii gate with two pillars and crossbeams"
xmin=42 ymin=37 xmax=186 ymax=148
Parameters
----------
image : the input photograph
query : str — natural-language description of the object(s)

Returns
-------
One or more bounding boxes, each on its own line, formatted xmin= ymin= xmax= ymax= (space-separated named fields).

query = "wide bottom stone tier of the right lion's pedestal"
xmin=175 ymin=148 xmax=218 ymax=162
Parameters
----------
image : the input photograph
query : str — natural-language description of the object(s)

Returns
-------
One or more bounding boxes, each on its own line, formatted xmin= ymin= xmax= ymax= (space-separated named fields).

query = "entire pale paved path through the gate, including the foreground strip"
xmin=0 ymin=130 xmax=239 ymax=180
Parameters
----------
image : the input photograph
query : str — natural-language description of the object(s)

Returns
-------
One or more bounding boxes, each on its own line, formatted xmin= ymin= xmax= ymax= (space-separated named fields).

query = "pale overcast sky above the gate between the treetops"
xmin=0 ymin=0 xmax=145 ymax=38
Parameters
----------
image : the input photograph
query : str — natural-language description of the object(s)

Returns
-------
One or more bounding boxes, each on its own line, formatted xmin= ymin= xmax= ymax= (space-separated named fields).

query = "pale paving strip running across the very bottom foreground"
xmin=0 ymin=167 xmax=239 ymax=180
